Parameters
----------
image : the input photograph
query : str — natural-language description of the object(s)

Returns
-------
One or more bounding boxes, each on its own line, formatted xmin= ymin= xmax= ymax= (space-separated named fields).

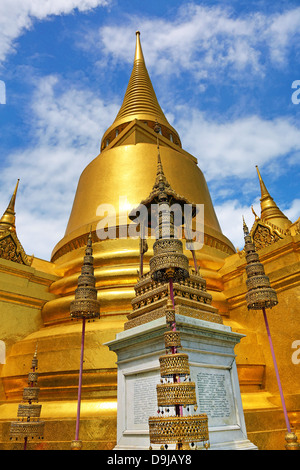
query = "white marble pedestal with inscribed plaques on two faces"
xmin=106 ymin=315 xmax=257 ymax=450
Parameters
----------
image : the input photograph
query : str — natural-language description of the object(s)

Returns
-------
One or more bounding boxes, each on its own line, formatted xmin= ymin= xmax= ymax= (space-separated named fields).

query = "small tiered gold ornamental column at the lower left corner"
xmin=10 ymin=350 xmax=45 ymax=450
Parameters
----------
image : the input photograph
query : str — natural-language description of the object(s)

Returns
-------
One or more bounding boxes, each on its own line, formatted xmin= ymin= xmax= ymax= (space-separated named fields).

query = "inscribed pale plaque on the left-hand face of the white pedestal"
xmin=126 ymin=373 xmax=159 ymax=430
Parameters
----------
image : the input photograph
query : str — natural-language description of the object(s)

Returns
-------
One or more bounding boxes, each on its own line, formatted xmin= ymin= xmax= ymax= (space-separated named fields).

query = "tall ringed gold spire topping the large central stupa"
xmin=101 ymin=31 xmax=180 ymax=149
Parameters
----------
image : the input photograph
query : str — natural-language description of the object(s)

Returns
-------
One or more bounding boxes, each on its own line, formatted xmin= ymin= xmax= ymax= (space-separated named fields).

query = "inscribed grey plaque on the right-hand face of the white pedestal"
xmin=196 ymin=369 xmax=236 ymax=426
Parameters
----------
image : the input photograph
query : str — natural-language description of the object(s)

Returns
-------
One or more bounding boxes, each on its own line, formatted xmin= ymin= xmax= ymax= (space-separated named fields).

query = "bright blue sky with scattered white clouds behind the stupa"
xmin=0 ymin=0 xmax=300 ymax=259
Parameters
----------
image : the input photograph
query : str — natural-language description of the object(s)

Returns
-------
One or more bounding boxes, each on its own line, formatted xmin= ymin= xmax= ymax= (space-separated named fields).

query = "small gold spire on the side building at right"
xmin=256 ymin=165 xmax=292 ymax=231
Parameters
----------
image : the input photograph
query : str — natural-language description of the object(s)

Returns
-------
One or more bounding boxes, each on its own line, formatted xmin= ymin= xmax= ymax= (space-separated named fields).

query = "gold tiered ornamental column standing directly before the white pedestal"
xmin=149 ymin=297 xmax=209 ymax=450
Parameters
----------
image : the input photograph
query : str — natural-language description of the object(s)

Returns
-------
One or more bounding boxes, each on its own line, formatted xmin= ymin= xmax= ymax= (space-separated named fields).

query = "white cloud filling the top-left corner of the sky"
xmin=0 ymin=0 xmax=110 ymax=62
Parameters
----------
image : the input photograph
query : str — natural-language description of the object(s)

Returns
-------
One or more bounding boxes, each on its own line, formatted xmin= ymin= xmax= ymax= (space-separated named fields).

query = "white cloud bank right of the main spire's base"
xmin=174 ymin=107 xmax=300 ymax=180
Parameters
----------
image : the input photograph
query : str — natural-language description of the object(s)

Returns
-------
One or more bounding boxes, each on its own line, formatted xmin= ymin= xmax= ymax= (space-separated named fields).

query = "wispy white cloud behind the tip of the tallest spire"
xmin=90 ymin=3 xmax=300 ymax=81
